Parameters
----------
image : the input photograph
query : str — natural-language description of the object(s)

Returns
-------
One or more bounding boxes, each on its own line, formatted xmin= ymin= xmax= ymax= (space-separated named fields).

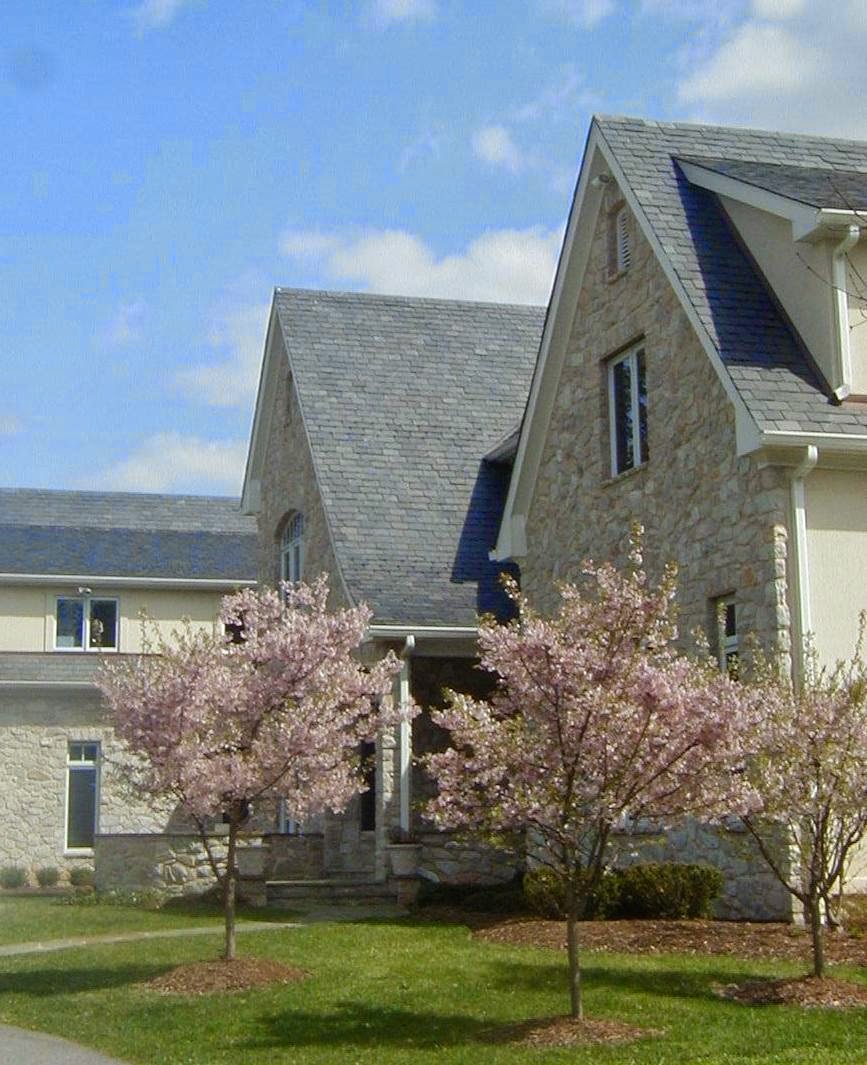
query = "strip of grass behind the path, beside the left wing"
xmin=0 ymin=897 xmax=292 ymax=945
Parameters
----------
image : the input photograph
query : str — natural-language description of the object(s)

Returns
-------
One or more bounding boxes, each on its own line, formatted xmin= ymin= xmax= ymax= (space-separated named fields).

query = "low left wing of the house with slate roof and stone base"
xmin=0 ymin=489 xmax=256 ymax=886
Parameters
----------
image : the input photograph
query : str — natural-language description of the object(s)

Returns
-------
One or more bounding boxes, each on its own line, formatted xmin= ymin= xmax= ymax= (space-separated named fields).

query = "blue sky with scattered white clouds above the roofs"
xmin=0 ymin=0 xmax=867 ymax=494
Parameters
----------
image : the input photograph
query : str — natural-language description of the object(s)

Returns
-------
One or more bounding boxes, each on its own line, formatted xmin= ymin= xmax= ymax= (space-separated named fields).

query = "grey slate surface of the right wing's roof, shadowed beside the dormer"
xmin=595 ymin=116 xmax=867 ymax=435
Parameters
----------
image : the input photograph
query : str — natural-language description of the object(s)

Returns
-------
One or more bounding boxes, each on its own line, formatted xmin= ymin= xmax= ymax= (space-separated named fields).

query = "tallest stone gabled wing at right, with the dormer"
xmin=495 ymin=118 xmax=867 ymax=916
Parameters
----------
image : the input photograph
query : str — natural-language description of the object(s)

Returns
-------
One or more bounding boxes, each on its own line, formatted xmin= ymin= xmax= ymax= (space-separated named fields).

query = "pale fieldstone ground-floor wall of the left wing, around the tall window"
xmin=0 ymin=688 xmax=171 ymax=883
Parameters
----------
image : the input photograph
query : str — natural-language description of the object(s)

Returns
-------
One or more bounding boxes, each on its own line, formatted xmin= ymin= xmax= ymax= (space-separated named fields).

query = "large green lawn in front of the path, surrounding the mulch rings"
xmin=0 ymin=910 xmax=867 ymax=1065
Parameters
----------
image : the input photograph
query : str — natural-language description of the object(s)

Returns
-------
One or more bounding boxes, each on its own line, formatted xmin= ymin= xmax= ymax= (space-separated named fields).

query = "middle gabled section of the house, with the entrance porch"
xmin=242 ymin=289 xmax=544 ymax=891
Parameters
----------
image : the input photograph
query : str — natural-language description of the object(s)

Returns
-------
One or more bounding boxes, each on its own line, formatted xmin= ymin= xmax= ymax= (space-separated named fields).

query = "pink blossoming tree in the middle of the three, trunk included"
xmin=429 ymin=541 xmax=740 ymax=1018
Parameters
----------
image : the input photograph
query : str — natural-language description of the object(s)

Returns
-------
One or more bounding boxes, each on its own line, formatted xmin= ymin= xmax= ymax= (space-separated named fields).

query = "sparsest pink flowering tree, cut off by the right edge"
xmin=743 ymin=623 xmax=867 ymax=977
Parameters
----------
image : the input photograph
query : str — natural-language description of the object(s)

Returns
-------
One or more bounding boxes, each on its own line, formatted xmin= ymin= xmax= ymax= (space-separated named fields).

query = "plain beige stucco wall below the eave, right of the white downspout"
xmin=806 ymin=470 xmax=867 ymax=665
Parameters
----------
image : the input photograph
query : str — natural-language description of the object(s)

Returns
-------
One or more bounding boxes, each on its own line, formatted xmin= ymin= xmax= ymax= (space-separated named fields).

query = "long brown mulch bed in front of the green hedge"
xmin=474 ymin=918 xmax=867 ymax=965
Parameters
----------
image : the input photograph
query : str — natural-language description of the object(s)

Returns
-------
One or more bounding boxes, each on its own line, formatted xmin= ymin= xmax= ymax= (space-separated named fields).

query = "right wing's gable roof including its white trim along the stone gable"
xmin=496 ymin=116 xmax=867 ymax=558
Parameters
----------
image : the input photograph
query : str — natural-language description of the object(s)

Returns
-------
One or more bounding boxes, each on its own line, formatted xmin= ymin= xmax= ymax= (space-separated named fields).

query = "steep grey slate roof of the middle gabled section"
xmin=275 ymin=289 xmax=544 ymax=625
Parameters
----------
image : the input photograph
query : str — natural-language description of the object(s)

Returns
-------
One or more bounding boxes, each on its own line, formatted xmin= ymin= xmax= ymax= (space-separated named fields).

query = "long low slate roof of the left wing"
xmin=0 ymin=488 xmax=256 ymax=580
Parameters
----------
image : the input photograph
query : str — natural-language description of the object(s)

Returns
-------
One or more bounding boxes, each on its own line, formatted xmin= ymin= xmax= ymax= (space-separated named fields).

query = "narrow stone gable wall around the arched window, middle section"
xmin=258 ymin=333 xmax=345 ymax=606
